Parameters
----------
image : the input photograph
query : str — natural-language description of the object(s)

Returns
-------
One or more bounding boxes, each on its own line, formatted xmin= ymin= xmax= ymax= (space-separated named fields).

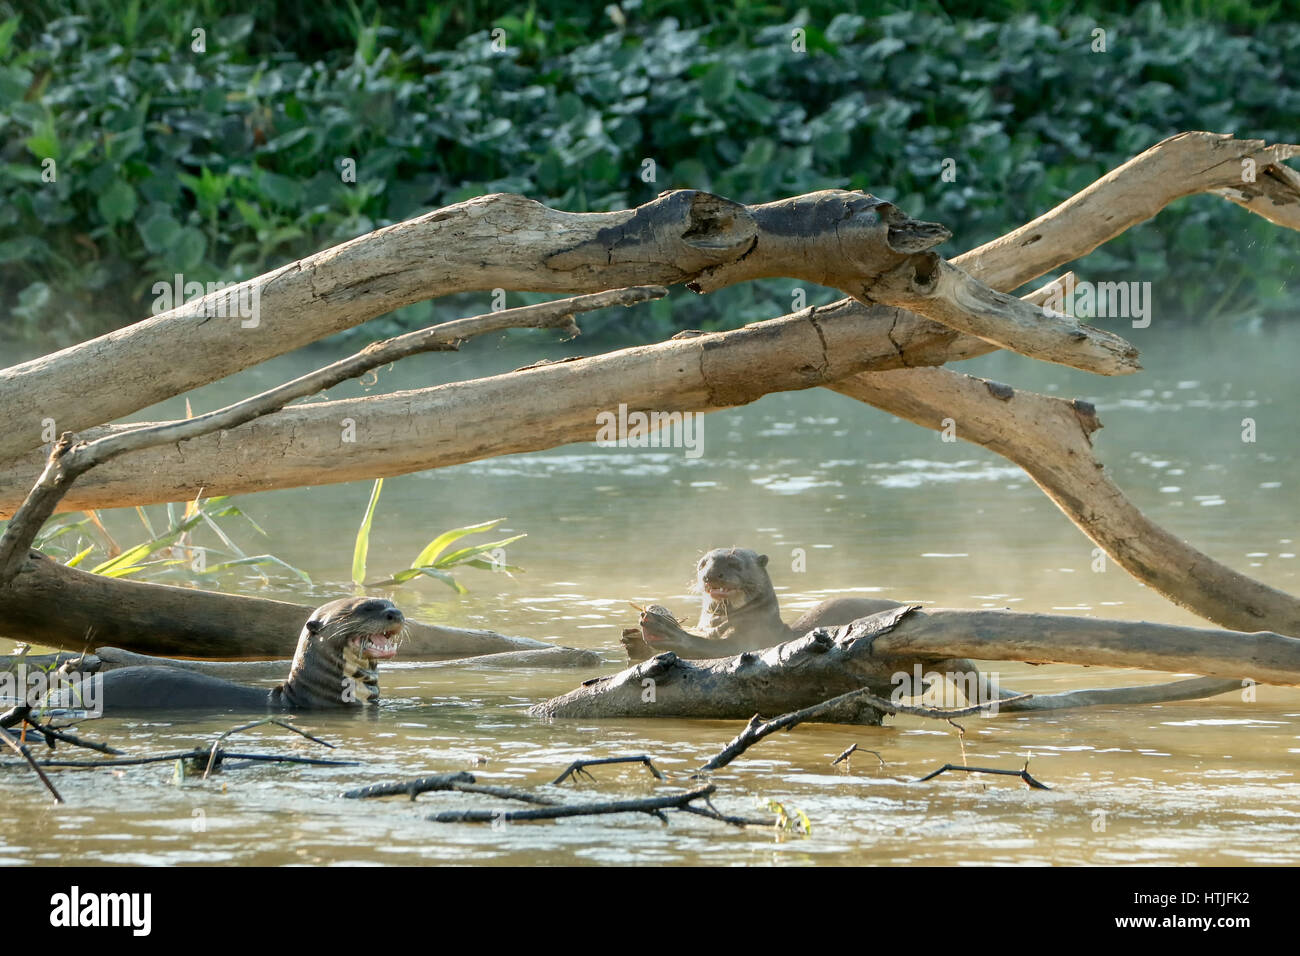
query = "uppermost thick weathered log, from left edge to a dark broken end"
xmin=0 ymin=190 xmax=949 ymax=460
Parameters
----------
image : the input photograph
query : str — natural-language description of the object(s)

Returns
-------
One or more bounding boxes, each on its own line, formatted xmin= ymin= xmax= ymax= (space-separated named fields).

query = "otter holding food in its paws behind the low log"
xmin=623 ymin=548 xmax=901 ymax=661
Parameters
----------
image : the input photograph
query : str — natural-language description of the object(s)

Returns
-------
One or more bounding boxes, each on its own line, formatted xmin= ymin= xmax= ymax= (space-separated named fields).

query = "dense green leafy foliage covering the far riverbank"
xmin=0 ymin=0 xmax=1300 ymax=345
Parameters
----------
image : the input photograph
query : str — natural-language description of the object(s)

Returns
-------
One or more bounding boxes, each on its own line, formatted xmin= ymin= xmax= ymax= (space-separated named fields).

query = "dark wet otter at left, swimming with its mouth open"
xmin=83 ymin=597 xmax=406 ymax=713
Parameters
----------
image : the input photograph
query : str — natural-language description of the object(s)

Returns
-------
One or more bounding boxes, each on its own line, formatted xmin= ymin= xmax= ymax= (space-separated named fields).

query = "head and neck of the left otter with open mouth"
xmin=278 ymin=597 xmax=406 ymax=708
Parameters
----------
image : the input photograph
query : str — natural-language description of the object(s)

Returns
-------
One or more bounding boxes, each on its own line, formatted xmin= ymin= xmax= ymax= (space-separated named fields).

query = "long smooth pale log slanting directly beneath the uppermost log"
xmin=0 ymin=277 xmax=1056 ymax=518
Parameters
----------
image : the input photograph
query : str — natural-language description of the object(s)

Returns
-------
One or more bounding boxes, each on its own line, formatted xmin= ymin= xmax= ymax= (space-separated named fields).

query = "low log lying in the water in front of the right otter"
xmin=529 ymin=606 xmax=1300 ymax=723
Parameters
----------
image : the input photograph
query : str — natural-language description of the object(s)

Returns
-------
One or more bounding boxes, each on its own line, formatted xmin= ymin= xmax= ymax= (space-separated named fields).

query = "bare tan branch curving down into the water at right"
xmin=835 ymin=368 xmax=1300 ymax=636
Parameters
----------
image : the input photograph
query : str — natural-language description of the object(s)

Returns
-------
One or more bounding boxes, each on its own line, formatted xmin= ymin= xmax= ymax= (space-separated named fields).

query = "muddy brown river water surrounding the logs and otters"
xmin=0 ymin=323 xmax=1300 ymax=865
